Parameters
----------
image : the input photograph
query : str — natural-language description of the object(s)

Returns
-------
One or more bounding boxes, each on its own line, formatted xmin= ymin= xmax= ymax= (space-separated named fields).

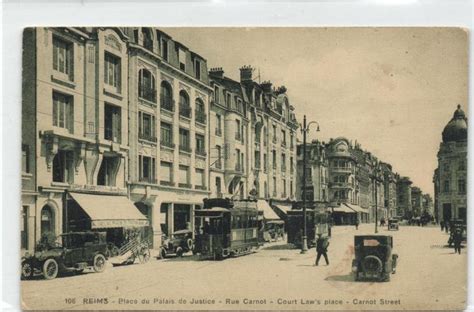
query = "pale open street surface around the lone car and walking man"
xmin=21 ymin=225 xmax=467 ymax=310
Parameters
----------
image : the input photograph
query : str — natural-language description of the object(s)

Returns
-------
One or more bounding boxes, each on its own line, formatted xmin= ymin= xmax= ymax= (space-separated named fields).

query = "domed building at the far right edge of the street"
xmin=434 ymin=105 xmax=467 ymax=221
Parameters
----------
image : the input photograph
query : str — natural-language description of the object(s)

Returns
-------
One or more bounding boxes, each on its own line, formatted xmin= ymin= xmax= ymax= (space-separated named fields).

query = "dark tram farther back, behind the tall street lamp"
xmin=286 ymin=209 xmax=330 ymax=248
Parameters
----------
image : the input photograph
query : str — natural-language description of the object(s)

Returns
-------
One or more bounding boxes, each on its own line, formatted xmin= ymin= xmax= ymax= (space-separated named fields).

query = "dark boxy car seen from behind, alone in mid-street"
xmin=352 ymin=235 xmax=398 ymax=282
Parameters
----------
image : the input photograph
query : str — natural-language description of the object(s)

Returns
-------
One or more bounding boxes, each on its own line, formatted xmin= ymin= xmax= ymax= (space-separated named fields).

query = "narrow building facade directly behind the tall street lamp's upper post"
xmin=296 ymin=140 xmax=329 ymax=202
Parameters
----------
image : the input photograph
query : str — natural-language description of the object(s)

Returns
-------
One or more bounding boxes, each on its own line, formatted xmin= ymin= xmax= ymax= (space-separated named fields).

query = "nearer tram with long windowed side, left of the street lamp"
xmin=194 ymin=198 xmax=261 ymax=260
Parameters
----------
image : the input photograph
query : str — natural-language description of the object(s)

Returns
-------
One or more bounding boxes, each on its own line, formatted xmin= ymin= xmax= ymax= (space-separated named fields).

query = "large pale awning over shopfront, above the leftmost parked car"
xmin=69 ymin=192 xmax=148 ymax=229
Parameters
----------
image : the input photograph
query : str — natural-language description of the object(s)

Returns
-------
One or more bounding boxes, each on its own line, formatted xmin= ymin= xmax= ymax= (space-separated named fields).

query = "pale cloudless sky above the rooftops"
xmin=163 ymin=28 xmax=468 ymax=195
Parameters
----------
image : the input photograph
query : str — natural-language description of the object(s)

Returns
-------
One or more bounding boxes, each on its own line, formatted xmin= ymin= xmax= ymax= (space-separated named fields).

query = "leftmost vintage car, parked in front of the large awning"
xmin=21 ymin=232 xmax=107 ymax=279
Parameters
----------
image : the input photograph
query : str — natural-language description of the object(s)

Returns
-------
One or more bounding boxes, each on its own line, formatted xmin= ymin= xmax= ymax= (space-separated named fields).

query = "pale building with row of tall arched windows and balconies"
xmin=124 ymin=27 xmax=212 ymax=248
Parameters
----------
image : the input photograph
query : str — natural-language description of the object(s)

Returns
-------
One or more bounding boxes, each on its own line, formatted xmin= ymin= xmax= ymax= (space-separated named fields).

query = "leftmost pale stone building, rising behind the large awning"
xmin=21 ymin=28 xmax=134 ymax=255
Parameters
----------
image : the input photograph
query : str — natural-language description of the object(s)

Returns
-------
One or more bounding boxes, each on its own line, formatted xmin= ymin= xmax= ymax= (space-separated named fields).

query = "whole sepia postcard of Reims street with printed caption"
xmin=18 ymin=27 xmax=469 ymax=310
